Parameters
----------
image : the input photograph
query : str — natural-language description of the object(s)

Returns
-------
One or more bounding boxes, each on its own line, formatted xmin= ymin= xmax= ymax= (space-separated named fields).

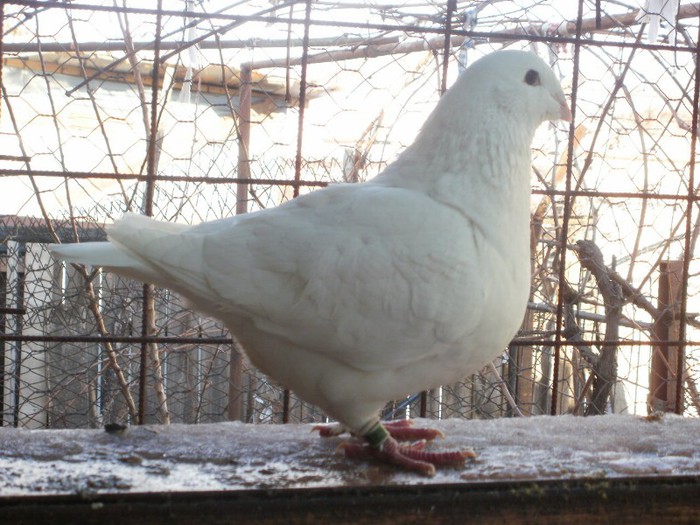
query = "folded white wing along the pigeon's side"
xmin=98 ymin=184 xmax=487 ymax=370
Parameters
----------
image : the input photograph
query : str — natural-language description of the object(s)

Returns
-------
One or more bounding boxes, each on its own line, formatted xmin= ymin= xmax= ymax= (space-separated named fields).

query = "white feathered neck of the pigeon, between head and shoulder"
xmin=376 ymin=110 xmax=534 ymax=248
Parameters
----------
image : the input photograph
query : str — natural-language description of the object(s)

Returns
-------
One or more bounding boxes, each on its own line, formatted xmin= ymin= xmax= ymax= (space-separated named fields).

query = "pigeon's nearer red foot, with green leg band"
xmin=340 ymin=423 xmax=476 ymax=477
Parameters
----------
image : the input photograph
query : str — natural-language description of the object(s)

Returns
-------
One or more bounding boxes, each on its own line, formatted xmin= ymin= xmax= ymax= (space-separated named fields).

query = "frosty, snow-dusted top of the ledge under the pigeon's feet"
xmin=0 ymin=415 xmax=700 ymax=496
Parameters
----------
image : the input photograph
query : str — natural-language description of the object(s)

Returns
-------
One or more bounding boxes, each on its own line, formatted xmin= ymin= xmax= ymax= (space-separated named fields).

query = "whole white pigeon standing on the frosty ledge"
xmin=51 ymin=50 xmax=571 ymax=475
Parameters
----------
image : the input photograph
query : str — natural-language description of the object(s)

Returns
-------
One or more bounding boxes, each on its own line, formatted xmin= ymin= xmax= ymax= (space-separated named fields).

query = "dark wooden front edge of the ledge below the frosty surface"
xmin=0 ymin=476 xmax=700 ymax=525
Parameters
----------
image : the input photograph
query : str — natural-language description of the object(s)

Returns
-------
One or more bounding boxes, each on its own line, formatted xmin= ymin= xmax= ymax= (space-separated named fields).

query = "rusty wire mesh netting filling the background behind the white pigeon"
xmin=0 ymin=0 xmax=700 ymax=428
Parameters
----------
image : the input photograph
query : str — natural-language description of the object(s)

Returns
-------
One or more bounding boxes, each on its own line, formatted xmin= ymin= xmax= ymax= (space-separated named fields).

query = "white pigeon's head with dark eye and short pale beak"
xmin=464 ymin=50 xmax=571 ymax=127
